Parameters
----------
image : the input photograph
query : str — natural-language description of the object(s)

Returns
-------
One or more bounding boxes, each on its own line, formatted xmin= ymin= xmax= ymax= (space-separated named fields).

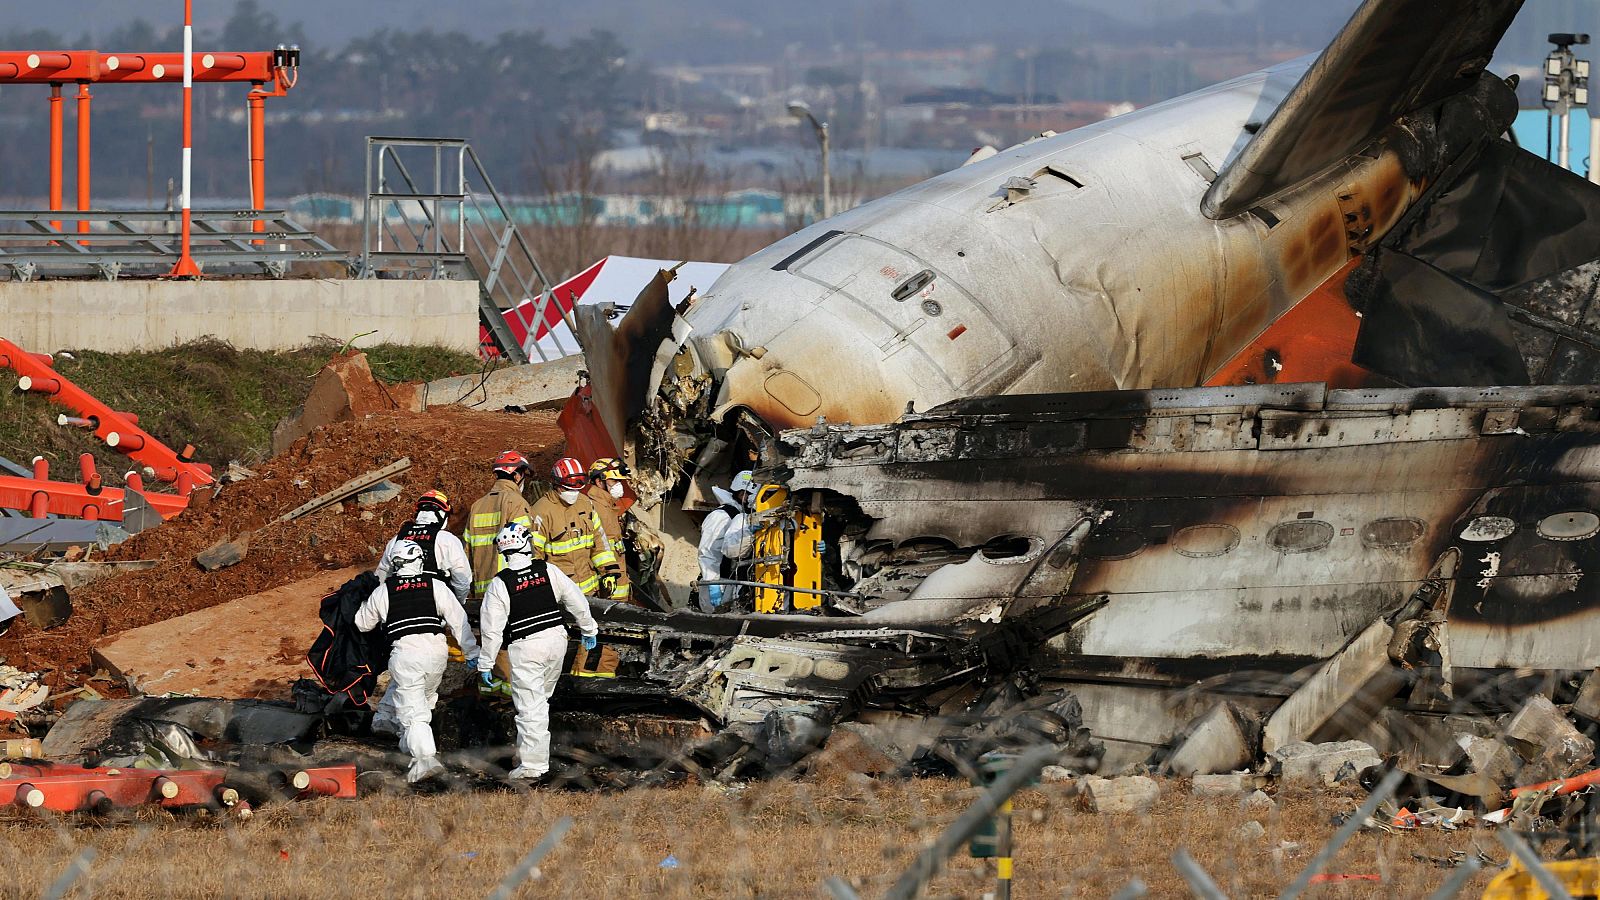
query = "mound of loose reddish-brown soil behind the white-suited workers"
xmin=0 ymin=407 xmax=563 ymax=690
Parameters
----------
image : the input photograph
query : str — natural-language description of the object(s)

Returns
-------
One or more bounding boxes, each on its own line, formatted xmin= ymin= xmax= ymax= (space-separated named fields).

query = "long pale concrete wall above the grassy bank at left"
xmin=0 ymin=279 xmax=478 ymax=352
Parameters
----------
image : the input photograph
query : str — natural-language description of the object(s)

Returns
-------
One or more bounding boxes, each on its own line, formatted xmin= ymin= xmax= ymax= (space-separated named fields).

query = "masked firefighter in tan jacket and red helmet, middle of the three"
xmin=528 ymin=456 xmax=622 ymax=597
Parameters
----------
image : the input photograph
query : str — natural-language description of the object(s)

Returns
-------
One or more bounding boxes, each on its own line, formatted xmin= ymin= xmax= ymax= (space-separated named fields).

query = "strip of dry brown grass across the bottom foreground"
xmin=0 ymin=775 xmax=1506 ymax=898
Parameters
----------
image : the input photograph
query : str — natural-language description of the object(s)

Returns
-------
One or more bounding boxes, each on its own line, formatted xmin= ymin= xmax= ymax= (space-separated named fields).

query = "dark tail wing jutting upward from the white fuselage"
xmin=1202 ymin=0 xmax=1523 ymax=219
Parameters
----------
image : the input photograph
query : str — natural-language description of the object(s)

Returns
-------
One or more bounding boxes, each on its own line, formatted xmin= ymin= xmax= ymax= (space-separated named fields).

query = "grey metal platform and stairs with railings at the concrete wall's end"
xmin=360 ymin=138 xmax=576 ymax=364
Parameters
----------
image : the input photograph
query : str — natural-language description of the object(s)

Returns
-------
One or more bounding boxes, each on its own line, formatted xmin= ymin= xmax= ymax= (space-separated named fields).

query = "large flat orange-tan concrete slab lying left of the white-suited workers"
xmin=93 ymin=569 xmax=365 ymax=700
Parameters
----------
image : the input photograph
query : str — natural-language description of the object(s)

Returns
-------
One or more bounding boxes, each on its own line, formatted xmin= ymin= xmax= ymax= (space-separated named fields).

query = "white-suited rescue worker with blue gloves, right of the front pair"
xmin=478 ymin=522 xmax=600 ymax=780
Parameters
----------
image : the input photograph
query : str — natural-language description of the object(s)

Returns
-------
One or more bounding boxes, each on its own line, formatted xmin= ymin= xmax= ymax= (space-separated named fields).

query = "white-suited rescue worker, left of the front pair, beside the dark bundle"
xmin=355 ymin=541 xmax=478 ymax=781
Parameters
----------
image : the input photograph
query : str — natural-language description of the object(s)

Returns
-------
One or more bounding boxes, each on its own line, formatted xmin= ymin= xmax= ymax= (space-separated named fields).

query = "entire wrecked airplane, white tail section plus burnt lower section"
xmin=563 ymin=0 xmax=1600 ymax=762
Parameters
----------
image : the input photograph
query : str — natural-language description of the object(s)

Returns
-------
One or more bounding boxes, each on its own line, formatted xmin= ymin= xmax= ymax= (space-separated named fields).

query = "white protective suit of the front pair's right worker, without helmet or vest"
xmin=478 ymin=552 xmax=600 ymax=778
